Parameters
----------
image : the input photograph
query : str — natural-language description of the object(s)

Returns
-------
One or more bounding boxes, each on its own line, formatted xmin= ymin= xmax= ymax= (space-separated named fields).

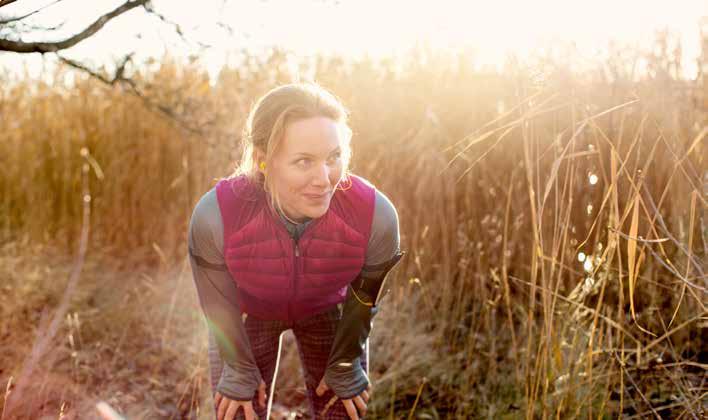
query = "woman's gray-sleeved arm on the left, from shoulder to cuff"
xmin=188 ymin=189 xmax=261 ymax=401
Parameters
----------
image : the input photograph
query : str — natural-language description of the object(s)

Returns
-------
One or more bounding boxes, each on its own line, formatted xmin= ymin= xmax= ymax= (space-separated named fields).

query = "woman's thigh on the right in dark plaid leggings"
xmin=293 ymin=306 xmax=366 ymax=419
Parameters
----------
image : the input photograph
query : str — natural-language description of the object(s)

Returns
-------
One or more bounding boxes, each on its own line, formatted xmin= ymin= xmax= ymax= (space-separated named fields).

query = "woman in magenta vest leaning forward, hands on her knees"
xmin=189 ymin=84 xmax=403 ymax=419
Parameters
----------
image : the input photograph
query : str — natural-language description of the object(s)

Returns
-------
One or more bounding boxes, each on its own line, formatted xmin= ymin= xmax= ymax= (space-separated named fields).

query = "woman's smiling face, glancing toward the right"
xmin=266 ymin=117 xmax=344 ymax=222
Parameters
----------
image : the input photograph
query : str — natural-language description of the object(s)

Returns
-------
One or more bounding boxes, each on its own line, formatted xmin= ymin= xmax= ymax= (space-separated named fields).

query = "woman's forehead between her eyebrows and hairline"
xmin=282 ymin=117 xmax=343 ymax=156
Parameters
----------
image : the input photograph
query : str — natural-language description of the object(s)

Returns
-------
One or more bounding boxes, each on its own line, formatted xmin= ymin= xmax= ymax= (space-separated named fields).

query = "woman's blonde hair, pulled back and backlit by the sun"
xmin=231 ymin=82 xmax=352 ymax=222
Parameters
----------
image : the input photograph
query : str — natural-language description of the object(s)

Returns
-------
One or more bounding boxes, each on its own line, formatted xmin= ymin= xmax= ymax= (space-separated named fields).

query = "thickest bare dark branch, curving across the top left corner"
xmin=0 ymin=0 xmax=149 ymax=54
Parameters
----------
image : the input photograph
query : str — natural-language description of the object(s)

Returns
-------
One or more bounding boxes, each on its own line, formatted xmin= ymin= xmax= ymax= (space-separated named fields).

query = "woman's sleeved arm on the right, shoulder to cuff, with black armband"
xmin=324 ymin=190 xmax=404 ymax=399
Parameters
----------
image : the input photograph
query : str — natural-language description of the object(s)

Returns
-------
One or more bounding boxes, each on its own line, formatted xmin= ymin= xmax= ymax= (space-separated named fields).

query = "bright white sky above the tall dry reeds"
xmin=0 ymin=0 xmax=708 ymax=79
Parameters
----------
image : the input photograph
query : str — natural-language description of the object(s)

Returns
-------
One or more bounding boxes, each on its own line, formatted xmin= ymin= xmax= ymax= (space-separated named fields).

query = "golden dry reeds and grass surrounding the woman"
xmin=0 ymin=33 xmax=708 ymax=418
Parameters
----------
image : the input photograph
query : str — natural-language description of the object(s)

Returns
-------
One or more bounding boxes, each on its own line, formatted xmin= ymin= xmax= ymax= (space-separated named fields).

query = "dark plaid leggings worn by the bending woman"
xmin=209 ymin=306 xmax=368 ymax=420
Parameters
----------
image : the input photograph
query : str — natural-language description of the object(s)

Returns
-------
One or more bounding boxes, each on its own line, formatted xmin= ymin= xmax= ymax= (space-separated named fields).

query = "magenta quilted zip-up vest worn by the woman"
xmin=216 ymin=174 xmax=375 ymax=321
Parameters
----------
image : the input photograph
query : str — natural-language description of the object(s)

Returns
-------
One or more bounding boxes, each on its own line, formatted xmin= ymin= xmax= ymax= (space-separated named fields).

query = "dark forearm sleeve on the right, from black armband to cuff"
xmin=324 ymin=252 xmax=405 ymax=399
